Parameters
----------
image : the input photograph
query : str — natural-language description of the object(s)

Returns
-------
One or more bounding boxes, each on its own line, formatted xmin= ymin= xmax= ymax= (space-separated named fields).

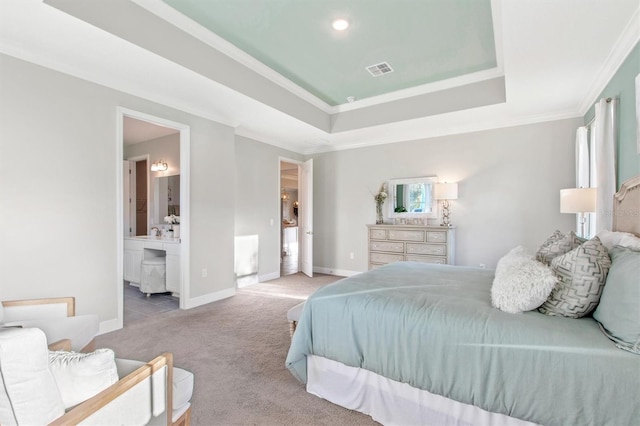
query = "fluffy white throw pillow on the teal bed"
xmin=491 ymin=246 xmax=558 ymax=314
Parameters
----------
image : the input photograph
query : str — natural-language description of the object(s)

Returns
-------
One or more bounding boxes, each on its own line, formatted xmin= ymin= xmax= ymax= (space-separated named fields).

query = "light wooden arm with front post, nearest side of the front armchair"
xmin=49 ymin=352 xmax=173 ymax=426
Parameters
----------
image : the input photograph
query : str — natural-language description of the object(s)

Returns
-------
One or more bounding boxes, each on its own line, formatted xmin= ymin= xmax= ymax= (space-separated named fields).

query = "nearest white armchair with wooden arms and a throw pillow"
xmin=0 ymin=328 xmax=193 ymax=426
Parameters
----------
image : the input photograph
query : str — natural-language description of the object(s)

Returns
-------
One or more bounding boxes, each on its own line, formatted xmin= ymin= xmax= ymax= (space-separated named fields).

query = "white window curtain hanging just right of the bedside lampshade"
xmin=591 ymin=98 xmax=617 ymax=232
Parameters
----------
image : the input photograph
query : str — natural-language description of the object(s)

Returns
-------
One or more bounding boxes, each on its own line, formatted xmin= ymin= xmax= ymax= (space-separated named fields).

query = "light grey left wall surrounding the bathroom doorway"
xmin=0 ymin=55 xmax=235 ymax=322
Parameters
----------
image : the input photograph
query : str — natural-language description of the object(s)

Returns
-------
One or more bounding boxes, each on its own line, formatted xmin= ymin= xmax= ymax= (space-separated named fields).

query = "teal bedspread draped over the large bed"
xmin=286 ymin=262 xmax=640 ymax=426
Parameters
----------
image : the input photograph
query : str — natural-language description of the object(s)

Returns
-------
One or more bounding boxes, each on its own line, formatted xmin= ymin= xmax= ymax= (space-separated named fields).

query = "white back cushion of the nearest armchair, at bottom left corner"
xmin=0 ymin=328 xmax=64 ymax=426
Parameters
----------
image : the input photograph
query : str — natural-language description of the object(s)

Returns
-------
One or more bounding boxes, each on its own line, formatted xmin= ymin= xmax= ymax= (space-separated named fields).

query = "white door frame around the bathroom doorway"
xmin=115 ymin=106 xmax=191 ymax=328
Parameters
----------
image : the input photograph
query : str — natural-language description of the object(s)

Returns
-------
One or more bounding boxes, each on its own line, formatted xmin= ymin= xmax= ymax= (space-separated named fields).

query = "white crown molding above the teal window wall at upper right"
xmin=578 ymin=6 xmax=640 ymax=116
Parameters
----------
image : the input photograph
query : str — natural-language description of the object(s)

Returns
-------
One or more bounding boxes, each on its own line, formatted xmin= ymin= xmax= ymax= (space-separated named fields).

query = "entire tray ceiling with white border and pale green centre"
xmin=0 ymin=0 xmax=640 ymax=154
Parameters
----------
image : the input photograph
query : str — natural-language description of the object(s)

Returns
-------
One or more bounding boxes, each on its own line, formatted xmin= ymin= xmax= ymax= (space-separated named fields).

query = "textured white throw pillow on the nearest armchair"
xmin=49 ymin=349 xmax=118 ymax=409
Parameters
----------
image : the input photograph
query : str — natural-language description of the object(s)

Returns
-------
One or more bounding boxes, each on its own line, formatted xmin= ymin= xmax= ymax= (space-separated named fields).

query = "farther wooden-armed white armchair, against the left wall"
xmin=0 ymin=297 xmax=98 ymax=352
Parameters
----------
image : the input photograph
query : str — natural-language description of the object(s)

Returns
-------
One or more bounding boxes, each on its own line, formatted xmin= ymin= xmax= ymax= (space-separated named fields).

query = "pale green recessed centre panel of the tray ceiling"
xmin=164 ymin=0 xmax=497 ymax=106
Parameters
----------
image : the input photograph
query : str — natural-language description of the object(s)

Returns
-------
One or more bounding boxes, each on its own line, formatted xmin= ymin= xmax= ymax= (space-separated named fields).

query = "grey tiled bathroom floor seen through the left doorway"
xmin=124 ymin=283 xmax=180 ymax=327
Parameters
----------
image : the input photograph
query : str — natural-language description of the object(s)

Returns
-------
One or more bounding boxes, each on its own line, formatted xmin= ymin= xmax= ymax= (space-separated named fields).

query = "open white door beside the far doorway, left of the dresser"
xmin=298 ymin=159 xmax=313 ymax=277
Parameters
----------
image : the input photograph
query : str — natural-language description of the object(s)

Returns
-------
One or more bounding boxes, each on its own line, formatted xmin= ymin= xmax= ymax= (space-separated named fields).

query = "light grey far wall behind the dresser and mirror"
xmin=313 ymin=118 xmax=582 ymax=273
